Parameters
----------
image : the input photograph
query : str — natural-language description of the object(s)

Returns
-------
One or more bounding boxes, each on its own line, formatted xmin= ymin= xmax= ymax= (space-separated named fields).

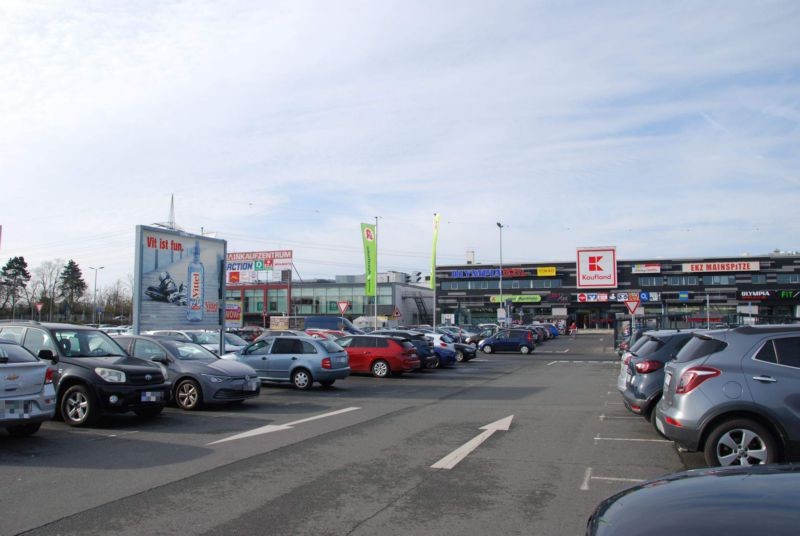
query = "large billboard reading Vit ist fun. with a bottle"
xmin=133 ymin=225 xmax=227 ymax=333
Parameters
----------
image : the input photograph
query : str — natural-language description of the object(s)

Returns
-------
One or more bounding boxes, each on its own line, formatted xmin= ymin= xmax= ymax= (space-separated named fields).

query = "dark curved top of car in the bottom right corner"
xmin=586 ymin=465 xmax=800 ymax=536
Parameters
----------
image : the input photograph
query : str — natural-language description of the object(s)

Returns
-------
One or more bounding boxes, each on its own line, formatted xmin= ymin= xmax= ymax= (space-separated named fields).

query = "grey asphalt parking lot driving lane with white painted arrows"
xmin=0 ymin=332 xmax=702 ymax=535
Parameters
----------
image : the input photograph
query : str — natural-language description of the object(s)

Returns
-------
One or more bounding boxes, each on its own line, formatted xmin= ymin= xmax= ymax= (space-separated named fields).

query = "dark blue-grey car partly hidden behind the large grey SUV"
xmin=622 ymin=331 xmax=692 ymax=432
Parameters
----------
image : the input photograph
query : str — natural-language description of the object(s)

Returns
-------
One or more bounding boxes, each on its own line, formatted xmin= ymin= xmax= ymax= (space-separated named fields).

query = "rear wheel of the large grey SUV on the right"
xmin=703 ymin=419 xmax=778 ymax=467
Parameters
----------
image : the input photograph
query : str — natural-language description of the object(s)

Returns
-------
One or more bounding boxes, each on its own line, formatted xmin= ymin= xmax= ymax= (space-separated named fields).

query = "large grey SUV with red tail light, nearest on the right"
xmin=656 ymin=325 xmax=800 ymax=465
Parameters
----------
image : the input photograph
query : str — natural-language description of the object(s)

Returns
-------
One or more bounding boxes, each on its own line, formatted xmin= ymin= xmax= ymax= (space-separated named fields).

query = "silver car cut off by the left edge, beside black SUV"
xmin=0 ymin=339 xmax=58 ymax=436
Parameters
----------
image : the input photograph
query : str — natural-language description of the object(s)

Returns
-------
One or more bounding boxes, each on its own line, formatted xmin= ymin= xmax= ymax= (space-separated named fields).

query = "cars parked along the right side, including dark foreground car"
xmin=586 ymin=325 xmax=800 ymax=535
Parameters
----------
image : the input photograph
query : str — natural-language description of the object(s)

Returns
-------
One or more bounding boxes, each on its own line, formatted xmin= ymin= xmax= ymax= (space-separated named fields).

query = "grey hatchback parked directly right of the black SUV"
xmin=115 ymin=335 xmax=261 ymax=410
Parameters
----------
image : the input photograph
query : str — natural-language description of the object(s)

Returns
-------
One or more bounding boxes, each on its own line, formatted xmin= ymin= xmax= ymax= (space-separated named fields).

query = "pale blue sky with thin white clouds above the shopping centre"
xmin=0 ymin=0 xmax=800 ymax=286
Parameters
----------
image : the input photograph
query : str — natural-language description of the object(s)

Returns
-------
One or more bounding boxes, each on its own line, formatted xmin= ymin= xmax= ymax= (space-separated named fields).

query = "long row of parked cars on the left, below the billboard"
xmin=0 ymin=321 xmax=488 ymax=436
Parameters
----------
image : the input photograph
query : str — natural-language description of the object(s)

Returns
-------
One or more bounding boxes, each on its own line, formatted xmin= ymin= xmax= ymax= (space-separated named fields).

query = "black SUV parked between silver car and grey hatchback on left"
xmin=0 ymin=321 xmax=171 ymax=426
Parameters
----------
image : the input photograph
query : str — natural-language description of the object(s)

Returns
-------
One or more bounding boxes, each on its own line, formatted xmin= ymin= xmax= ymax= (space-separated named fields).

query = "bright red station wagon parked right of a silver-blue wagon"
xmin=336 ymin=335 xmax=419 ymax=378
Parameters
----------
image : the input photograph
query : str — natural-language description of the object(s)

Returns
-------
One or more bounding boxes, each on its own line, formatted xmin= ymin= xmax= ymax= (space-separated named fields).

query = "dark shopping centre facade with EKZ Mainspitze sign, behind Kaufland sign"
xmin=436 ymin=254 xmax=800 ymax=327
